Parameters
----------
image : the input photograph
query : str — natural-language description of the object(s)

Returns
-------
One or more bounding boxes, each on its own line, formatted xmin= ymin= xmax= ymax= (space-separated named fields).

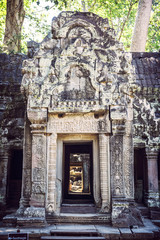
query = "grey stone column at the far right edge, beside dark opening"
xmin=145 ymin=148 xmax=160 ymax=207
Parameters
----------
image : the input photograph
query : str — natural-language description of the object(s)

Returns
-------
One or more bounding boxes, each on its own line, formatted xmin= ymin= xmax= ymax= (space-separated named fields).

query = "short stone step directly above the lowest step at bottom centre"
xmin=50 ymin=229 xmax=98 ymax=237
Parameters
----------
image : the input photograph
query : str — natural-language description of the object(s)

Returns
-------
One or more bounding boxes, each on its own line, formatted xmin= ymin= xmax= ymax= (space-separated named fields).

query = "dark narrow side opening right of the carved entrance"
xmin=134 ymin=148 xmax=147 ymax=203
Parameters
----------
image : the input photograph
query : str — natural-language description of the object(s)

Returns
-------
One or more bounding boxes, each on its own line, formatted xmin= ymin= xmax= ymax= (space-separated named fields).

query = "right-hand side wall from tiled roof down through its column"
xmin=132 ymin=53 xmax=160 ymax=207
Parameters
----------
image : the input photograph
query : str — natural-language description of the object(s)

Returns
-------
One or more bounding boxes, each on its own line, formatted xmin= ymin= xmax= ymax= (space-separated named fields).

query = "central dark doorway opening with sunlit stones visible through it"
xmin=63 ymin=142 xmax=93 ymax=203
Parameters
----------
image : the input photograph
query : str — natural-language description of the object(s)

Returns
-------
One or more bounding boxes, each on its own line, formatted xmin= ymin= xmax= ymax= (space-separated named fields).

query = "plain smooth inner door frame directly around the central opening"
xmin=56 ymin=134 xmax=101 ymax=209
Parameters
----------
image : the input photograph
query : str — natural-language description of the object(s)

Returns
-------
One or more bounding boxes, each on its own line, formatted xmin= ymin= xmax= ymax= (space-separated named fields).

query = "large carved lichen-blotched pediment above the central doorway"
xmin=22 ymin=12 xmax=132 ymax=113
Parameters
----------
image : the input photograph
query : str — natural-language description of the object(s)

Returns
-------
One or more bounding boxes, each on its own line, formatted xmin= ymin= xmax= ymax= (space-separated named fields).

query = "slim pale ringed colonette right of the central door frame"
xmin=99 ymin=133 xmax=110 ymax=213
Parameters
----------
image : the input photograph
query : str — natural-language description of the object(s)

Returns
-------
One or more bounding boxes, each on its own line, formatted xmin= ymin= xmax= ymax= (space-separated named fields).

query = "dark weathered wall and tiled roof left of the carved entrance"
xmin=0 ymin=53 xmax=26 ymax=216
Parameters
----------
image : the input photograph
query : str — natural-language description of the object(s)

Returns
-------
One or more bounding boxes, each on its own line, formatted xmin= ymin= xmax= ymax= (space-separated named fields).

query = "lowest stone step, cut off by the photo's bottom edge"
xmin=41 ymin=236 xmax=105 ymax=240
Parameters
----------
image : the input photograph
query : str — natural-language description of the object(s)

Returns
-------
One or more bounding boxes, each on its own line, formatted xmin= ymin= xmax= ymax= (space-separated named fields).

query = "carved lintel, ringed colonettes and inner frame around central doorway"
xmin=45 ymin=113 xmax=111 ymax=214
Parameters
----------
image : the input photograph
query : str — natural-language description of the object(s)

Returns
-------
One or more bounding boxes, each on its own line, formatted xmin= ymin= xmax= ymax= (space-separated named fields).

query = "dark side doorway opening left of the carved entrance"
xmin=7 ymin=149 xmax=23 ymax=208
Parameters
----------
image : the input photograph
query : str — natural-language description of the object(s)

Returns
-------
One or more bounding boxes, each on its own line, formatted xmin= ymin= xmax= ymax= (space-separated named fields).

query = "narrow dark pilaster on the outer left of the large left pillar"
xmin=18 ymin=116 xmax=32 ymax=210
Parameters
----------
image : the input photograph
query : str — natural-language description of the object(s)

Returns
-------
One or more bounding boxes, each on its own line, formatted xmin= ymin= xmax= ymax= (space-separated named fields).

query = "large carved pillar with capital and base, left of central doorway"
xmin=24 ymin=108 xmax=47 ymax=218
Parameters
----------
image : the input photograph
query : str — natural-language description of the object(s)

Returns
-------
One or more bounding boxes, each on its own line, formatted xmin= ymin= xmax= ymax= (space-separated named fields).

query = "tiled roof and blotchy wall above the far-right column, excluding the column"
xmin=132 ymin=53 xmax=160 ymax=150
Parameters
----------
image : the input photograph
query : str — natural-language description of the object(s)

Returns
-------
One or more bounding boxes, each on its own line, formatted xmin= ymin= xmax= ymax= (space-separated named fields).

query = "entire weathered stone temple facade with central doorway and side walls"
xmin=0 ymin=12 xmax=160 ymax=236
